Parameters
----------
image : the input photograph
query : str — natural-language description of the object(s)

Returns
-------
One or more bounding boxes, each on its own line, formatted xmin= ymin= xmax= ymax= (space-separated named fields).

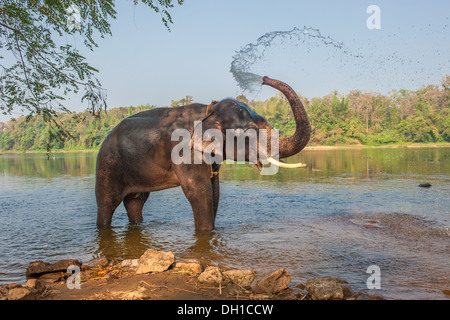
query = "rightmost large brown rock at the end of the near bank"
xmin=305 ymin=277 xmax=353 ymax=300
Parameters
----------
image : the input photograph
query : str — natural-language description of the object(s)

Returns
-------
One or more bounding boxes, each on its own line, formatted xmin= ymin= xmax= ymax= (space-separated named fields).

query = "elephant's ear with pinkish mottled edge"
xmin=191 ymin=110 xmax=225 ymax=164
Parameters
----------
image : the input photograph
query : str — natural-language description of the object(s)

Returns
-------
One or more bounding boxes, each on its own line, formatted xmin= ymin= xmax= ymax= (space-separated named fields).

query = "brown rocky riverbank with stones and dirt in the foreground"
xmin=0 ymin=249 xmax=383 ymax=300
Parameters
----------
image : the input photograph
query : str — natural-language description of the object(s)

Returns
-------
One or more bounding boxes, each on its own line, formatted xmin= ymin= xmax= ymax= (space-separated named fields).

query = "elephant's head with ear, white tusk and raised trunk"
xmin=194 ymin=77 xmax=311 ymax=170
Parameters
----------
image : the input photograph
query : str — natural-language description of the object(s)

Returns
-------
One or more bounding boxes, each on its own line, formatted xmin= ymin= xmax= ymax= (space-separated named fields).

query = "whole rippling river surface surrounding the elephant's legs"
xmin=0 ymin=148 xmax=450 ymax=298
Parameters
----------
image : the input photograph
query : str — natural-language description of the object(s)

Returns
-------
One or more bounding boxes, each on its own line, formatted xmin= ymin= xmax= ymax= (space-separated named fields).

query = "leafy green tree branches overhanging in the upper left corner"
xmin=0 ymin=0 xmax=183 ymax=149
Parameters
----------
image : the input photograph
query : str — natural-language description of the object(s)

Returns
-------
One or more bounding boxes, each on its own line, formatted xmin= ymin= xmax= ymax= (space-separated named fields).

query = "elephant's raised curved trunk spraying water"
xmin=262 ymin=77 xmax=311 ymax=159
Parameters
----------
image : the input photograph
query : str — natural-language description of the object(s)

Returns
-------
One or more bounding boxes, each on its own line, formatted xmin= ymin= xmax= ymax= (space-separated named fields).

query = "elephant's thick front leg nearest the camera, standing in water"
xmin=178 ymin=165 xmax=215 ymax=231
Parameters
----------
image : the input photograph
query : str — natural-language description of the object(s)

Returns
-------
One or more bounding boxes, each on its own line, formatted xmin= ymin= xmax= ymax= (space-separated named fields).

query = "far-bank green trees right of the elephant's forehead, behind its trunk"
xmin=250 ymin=76 xmax=450 ymax=145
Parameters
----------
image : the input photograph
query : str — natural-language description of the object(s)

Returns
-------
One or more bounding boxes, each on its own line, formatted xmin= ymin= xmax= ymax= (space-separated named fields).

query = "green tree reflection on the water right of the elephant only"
xmin=220 ymin=148 xmax=450 ymax=182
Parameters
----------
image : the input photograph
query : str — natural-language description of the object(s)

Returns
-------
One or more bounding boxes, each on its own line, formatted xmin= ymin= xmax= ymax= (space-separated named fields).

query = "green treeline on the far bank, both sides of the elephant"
xmin=0 ymin=76 xmax=450 ymax=151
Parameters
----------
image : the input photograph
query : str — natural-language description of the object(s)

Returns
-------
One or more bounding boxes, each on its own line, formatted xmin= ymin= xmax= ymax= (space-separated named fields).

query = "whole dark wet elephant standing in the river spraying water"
xmin=95 ymin=77 xmax=311 ymax=231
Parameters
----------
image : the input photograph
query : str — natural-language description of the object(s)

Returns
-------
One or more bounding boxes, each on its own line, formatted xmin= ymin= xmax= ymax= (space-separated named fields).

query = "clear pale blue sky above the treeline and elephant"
xmin=5 ymin=0 xmax=450 ymax=120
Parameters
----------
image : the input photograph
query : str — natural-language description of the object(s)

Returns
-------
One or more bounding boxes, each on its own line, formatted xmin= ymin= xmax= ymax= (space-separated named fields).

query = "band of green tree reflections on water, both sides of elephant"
xmin=0 ymin=148 xmax=450 ymax=182
